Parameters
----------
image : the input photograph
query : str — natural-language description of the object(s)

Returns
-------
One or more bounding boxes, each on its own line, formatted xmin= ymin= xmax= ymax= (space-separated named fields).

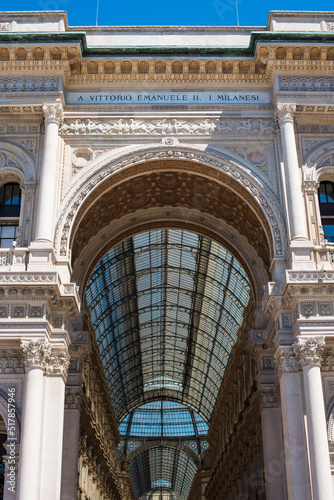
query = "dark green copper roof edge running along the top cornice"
xmin=0 ymin=31 xmax=334 ymax=57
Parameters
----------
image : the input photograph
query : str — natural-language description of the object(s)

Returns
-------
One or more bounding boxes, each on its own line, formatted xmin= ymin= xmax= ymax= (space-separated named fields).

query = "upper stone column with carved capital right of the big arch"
xmin=276 ymin=104 xmax=308 ymax=240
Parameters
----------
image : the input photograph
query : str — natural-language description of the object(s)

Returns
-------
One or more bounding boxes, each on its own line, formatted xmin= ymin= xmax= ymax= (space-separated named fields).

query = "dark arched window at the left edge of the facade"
xmin=0 ymin=182 xmax=21 ymax=248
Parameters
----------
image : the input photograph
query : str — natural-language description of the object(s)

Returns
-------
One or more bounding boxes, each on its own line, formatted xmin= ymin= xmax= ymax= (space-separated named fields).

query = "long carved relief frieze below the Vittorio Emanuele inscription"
xmin=61 ymin=118 xmax=276 ymax=136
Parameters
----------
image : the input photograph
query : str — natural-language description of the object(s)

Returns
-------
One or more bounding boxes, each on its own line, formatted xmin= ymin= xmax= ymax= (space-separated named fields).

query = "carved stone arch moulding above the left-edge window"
xmin=0 ymin=140 xmax=36 ymax=183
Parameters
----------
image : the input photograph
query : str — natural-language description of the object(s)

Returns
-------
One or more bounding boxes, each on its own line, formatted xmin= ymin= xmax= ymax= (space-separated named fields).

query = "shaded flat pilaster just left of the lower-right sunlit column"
xmin=275 ymin=346 xmax=311 ymax=500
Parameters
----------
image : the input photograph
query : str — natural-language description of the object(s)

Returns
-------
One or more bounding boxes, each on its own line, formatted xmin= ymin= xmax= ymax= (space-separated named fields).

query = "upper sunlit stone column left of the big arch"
xmin=35 ymin=103 xmax=62 ymax=243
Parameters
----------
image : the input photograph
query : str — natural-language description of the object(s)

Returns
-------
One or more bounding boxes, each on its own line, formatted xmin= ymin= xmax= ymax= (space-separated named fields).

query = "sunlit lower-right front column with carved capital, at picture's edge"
xmin=296 ymin=337 xmax=333 ymax=500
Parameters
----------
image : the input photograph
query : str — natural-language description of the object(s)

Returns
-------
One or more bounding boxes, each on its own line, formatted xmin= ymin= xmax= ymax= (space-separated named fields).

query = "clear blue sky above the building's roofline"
xmin=0 ymin=0 xmax=334 ymax=26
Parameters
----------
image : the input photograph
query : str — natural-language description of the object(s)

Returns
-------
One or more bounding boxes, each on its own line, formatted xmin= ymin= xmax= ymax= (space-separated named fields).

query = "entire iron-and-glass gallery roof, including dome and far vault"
xmin=86 ymin=229 xmax=250 ymax=500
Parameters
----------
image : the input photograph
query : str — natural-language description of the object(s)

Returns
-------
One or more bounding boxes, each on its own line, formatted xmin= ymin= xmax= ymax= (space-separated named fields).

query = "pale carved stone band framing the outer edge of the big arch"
xmin=55 ymin=146 xmax=286 ymax=256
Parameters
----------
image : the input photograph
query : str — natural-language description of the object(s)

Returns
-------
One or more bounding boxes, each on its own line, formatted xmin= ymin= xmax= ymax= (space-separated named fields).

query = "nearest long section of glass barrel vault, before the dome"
xmin=86 ymin=229 xmax=250 ymax=422
